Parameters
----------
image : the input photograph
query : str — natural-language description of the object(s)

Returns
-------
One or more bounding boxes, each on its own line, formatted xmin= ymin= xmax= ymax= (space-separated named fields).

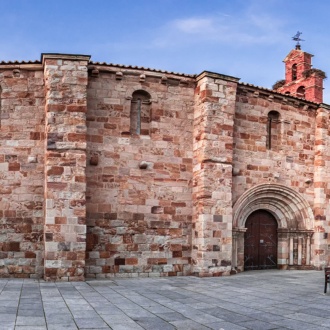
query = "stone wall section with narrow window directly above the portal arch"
xmin=233 ymin=85 xmax=317 ymax=206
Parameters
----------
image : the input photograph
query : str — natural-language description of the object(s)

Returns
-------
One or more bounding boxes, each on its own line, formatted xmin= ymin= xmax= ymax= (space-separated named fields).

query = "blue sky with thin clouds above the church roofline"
xmin=0 ymin=0 xmax=330 ymax=104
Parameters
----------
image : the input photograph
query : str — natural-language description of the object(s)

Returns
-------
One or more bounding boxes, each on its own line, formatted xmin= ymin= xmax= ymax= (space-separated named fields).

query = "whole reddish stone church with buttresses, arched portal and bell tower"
xmin=0 ymin=45 xmax=330 ymax=281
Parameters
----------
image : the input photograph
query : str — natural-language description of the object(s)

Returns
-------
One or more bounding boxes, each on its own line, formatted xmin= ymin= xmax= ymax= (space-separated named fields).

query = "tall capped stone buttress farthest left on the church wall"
xmin=42 ymin=54 xmax=90 ymax=281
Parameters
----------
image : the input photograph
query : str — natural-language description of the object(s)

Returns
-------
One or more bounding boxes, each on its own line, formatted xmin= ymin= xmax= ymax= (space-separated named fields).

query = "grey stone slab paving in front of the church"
xmin=0 ymin=270 xmax=330 ymax=330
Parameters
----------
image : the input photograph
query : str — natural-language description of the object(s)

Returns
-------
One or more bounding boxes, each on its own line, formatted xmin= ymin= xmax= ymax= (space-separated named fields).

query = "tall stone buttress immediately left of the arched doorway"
xmin=192 ymin=72 xmax=238 ymax=276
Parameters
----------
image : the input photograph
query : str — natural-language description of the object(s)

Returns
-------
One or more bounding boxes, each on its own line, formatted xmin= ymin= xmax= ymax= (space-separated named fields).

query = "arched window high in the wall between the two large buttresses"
xmin=130 ymin=90 xmax=151 ymax=135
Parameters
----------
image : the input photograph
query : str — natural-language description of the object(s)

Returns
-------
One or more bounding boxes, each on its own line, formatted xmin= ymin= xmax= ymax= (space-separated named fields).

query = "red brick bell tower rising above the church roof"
xmin=275 ymin=43 xmax=326 ymax=103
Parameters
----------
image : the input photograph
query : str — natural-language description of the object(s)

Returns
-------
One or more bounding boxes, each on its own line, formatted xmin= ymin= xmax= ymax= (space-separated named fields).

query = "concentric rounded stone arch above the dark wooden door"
xmin=233 ymin=184 xmax=314 ymax=230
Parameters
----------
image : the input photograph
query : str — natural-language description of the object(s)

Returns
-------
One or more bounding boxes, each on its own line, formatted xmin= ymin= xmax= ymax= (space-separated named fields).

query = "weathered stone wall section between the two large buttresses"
xmin=86 ymin=66 xmax=194 ymax=277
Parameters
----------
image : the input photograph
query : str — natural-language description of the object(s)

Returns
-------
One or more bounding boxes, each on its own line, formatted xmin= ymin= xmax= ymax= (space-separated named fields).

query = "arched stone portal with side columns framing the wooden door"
xmin=232 ymin=184 xmax=314 ymax=271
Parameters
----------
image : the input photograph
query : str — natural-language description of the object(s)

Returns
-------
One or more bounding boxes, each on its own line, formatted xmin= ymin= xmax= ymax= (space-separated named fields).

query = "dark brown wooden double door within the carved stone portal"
xmin=244 ymin=210 xmax=277 ymax=270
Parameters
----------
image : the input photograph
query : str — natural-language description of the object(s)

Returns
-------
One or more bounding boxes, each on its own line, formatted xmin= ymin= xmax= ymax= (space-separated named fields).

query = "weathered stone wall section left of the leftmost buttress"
xmin=0 ymin=64 xmax=45 ymax=278
